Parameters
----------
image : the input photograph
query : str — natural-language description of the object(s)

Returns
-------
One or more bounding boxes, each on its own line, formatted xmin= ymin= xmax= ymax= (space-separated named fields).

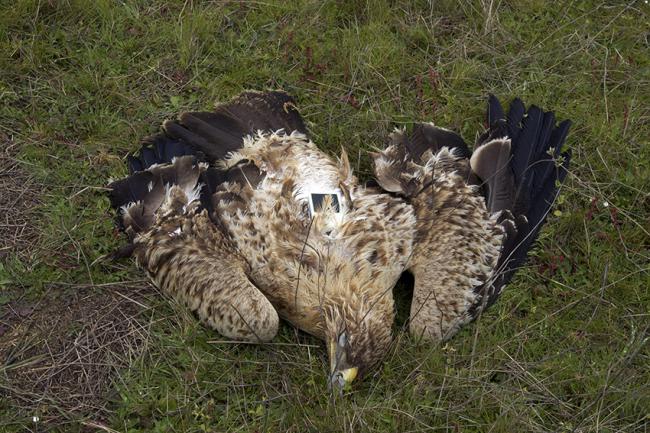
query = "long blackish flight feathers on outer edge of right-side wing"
xmin=471 ymin=95 xmax=571 ymax=311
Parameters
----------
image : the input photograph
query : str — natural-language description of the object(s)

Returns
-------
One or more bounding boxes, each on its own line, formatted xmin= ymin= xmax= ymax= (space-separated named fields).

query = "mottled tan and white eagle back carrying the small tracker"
xmin=209 ymin=133 xmax=413 ymax=338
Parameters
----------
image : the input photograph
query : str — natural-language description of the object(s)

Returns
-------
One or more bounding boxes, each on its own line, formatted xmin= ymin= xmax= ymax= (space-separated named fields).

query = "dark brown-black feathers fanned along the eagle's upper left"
xmin=109 ymin=91 xmax=307 ymax=241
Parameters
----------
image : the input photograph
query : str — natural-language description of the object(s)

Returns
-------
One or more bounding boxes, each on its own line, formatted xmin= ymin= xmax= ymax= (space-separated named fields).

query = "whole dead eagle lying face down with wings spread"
xmin=109 ymin=92 xmax=570 ymax=387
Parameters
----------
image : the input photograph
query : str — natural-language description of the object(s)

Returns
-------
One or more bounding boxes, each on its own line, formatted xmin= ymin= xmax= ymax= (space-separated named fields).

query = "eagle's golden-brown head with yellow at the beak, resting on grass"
xmin=323 ymin=290 xmax=394 ymax=392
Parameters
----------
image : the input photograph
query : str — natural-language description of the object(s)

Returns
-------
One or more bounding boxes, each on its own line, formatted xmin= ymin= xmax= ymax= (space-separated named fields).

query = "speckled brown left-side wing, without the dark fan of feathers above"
xmin=109 ymin=156 xmax=278 ymax=341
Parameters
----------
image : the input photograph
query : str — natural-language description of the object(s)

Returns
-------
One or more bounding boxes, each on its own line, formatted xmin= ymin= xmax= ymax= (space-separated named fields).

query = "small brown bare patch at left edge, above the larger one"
xmin=0 ymin=134 xmax=43 ymax=260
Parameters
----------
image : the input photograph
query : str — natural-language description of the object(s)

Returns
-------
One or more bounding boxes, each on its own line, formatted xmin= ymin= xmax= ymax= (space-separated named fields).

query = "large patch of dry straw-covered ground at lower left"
xmin=0 ymin=285 xmax=152 ymax=427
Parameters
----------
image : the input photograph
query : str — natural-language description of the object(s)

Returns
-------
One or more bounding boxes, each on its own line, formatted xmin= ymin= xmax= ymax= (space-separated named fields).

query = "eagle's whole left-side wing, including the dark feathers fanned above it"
xmin=109 ymin=92 xmax=306 ymax=341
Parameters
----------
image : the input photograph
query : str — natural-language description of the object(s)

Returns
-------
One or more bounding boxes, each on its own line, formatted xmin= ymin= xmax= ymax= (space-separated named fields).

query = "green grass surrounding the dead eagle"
xmin=0 ymin=0 xmax=650 ymax=433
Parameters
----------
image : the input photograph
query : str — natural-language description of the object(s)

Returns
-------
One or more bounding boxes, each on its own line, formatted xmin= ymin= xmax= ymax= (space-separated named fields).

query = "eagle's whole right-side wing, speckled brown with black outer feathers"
xmin=374 ymin=96 xmax=570 ymax=340
